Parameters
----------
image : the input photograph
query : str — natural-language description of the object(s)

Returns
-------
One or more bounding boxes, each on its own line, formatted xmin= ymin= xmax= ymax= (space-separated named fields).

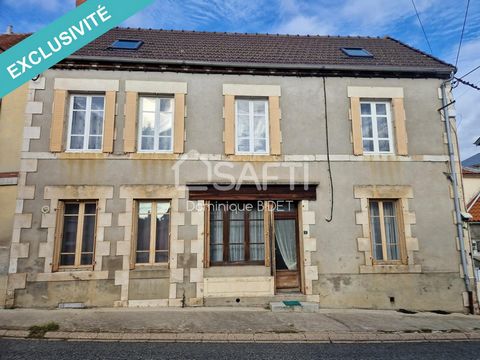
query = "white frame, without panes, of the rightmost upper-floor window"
xmin=359 ymin=100 xmax=395 ymax=154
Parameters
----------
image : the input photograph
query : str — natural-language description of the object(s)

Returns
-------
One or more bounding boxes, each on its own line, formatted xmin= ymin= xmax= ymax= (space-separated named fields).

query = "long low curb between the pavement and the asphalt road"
xmin=0 ymin=329 xmax=480 ymax=344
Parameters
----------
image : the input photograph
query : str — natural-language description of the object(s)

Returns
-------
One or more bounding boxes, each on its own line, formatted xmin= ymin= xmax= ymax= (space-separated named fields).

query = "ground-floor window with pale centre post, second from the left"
xmin=135 ymin=200 xmax=170 ymax=264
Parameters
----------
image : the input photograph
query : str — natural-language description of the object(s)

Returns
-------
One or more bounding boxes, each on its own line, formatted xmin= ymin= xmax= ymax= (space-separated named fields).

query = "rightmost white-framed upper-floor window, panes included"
xmin=360 ymin=101 xmax=393 ymax=154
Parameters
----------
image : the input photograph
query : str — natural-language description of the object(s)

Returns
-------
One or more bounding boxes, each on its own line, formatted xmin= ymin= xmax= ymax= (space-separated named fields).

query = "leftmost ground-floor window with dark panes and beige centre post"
xmin=58 ymin=201 xmax=97 ymax=267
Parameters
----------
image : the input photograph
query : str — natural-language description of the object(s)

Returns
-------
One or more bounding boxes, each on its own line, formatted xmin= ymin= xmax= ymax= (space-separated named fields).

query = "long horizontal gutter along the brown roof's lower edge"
xmin=64 ymin=55 xmax=452 ymax=77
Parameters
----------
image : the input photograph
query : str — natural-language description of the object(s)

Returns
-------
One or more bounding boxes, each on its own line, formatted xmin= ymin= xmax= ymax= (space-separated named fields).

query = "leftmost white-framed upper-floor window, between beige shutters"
xmin=67 ymin=95 xmax=105 ymax=151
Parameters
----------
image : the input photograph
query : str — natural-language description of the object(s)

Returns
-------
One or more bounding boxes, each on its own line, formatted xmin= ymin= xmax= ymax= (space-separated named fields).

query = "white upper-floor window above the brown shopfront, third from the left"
xmin=235 ymin=99 xmax=269 ymax=154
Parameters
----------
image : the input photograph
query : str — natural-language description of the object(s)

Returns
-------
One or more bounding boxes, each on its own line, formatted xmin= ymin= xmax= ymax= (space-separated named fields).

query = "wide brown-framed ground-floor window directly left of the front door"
xmin=210 ymin=202 xmax=265 ymax=265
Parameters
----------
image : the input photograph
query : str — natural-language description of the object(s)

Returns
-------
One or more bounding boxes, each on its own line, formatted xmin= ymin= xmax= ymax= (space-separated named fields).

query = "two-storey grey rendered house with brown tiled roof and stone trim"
xmin=2 ymin=28 xmax=473 ymax=312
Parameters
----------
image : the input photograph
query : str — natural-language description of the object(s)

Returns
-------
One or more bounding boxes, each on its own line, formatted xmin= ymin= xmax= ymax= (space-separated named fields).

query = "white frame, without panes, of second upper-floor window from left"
xmin=137 ymin=95 xmax=175 ymax=154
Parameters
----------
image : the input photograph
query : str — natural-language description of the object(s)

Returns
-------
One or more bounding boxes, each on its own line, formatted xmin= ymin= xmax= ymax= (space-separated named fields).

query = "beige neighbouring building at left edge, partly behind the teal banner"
xmin=0 ymin=27 xmax=28 ymax=307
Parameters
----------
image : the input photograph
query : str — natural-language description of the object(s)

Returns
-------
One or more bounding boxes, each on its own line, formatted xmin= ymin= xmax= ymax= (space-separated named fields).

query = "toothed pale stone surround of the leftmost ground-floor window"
xmin=35 ymin=186 xmax=113 ymax=281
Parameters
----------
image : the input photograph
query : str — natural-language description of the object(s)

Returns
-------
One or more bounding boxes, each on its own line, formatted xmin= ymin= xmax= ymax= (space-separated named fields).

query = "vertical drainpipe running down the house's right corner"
xmin=441 ymin=73 xmax=474 ymax=314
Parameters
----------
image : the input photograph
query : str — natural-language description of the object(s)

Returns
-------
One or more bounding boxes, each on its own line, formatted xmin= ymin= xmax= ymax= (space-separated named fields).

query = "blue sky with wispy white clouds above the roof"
xmin=0 ymin=0 xmax=480 ymax=159
